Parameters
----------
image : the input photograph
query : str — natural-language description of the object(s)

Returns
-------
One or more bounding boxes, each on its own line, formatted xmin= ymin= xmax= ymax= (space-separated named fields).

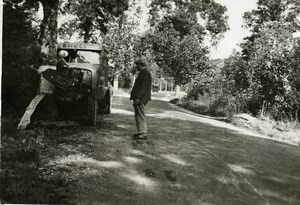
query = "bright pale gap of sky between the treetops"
xmin=211 ymin=0 xmax=257 ymax=59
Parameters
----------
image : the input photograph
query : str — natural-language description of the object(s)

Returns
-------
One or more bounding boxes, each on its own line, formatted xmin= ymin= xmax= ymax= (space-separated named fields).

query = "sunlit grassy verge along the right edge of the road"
xmin=173 ymin=97 xmax=300 ymax=146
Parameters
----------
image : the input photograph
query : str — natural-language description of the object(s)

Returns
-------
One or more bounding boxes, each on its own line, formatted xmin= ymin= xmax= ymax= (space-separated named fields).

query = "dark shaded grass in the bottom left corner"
xmin=0 ymin=115 xmax=69 ymax=204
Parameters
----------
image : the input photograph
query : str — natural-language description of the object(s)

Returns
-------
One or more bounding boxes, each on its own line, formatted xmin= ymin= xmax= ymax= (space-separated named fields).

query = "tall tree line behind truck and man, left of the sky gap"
xmin=2 ymin=0 xmax=228 ymax=112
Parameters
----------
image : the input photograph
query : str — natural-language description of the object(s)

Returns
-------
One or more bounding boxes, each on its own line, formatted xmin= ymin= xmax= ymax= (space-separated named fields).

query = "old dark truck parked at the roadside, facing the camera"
xmin=42 ymin=43 xmax=112 ymax=126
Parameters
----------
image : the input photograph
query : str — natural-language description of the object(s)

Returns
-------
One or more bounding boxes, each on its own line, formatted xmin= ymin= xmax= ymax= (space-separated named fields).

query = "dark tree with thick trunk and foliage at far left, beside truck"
xmin=3 ymin=0 xmax=59 ymax=113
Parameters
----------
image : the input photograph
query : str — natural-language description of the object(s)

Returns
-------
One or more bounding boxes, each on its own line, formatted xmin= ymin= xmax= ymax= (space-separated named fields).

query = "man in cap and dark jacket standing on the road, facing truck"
xmin=130 ymin=59 xmax=152 ymax=140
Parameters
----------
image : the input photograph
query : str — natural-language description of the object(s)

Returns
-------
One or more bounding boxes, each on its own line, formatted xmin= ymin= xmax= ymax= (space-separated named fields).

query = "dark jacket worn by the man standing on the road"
xmin=130 ymin=68 xmax=152 ymax=102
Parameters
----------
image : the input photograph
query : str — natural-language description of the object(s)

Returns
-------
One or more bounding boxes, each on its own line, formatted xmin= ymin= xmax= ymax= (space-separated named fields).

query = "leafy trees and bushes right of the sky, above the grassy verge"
xmin=223 ymin=0 xmax=300 ymax=119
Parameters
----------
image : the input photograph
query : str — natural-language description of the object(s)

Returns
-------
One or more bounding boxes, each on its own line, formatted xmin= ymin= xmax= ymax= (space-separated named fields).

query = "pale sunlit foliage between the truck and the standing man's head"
xmin=102 ymin=13 xmax=159 ymax=88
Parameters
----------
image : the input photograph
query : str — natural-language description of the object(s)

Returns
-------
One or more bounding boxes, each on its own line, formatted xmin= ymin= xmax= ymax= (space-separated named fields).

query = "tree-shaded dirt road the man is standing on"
xmin=21 ymin=97 xmax=300 ymax=205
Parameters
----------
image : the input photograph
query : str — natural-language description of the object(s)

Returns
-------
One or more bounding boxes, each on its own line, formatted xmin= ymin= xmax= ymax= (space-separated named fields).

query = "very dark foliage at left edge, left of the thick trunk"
xmin=2 ymin=1 xmax=41 ymax=112
